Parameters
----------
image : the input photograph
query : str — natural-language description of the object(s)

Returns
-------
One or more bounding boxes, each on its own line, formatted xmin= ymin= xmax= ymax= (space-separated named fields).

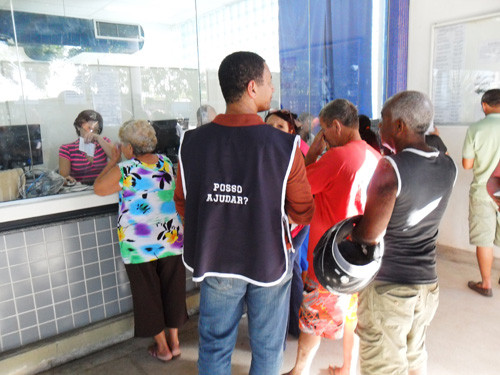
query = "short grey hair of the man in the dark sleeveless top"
xmin=382 ymin=91 xmax=434 ymax=134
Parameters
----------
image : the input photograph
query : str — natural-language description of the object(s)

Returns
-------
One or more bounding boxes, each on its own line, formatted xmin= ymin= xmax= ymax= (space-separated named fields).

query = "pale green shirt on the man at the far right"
xmin=462 ymin=113 xmax=500 ymax=200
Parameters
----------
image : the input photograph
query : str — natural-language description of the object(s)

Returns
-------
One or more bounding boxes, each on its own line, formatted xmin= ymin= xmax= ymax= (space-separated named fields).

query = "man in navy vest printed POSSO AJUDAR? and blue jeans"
xmin=174 ymin=52 xmax=314 ymax=375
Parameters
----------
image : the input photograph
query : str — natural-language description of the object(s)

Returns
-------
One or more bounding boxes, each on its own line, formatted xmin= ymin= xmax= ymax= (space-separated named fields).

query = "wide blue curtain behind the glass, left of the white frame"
xmin=279 ymin=0 xmax=372 ymax=116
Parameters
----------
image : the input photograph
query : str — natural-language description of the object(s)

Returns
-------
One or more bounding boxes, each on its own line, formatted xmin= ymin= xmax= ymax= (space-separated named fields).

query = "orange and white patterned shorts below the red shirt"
xmin=299 ymin=277 xmax=358 ymax=340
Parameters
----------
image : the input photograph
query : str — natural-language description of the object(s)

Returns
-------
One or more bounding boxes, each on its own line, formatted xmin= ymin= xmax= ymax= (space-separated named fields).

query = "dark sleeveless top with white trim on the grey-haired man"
xmin=376 ymin=149 xmax=457 ymax=284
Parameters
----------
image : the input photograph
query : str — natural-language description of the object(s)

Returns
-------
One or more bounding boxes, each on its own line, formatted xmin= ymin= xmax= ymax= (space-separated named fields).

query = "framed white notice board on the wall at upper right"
xmin=430 ymin=13 xmax=500 ymax=125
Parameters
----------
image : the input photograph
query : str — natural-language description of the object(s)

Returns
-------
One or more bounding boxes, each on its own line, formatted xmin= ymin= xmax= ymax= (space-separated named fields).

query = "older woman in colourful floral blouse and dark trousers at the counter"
xmin=94 ymin=120 xmax=188 ymax=361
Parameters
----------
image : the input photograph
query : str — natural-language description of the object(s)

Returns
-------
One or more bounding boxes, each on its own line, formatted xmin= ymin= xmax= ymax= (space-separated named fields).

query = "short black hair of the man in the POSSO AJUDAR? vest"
xmin=219 ymin=51 xmax=265 ymax=104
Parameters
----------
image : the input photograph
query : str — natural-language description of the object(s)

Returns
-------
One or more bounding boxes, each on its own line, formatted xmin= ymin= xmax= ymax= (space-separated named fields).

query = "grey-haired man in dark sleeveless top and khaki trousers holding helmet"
xmin=353 ymin=91 xmax=457 ymax=375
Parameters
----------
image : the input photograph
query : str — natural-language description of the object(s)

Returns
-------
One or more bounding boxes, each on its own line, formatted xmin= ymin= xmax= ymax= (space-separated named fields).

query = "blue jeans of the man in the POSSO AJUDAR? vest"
xmin=198 ymin=264 xmax=293 ymax=375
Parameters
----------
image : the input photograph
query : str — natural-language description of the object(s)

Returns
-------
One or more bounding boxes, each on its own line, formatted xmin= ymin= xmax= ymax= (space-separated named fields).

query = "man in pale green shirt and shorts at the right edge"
xmin=462 ymin=89 xmax=500 ymax=297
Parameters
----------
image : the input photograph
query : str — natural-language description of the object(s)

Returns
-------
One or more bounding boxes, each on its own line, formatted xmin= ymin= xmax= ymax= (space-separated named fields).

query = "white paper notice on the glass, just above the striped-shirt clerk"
xmin=92 ymin=70 xmax=122 ymax=126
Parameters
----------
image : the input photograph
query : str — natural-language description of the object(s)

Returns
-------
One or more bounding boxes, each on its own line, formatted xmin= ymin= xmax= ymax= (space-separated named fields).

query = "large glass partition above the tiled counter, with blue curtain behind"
xmin=0 ymin=0 xmax=386 ymax=207
